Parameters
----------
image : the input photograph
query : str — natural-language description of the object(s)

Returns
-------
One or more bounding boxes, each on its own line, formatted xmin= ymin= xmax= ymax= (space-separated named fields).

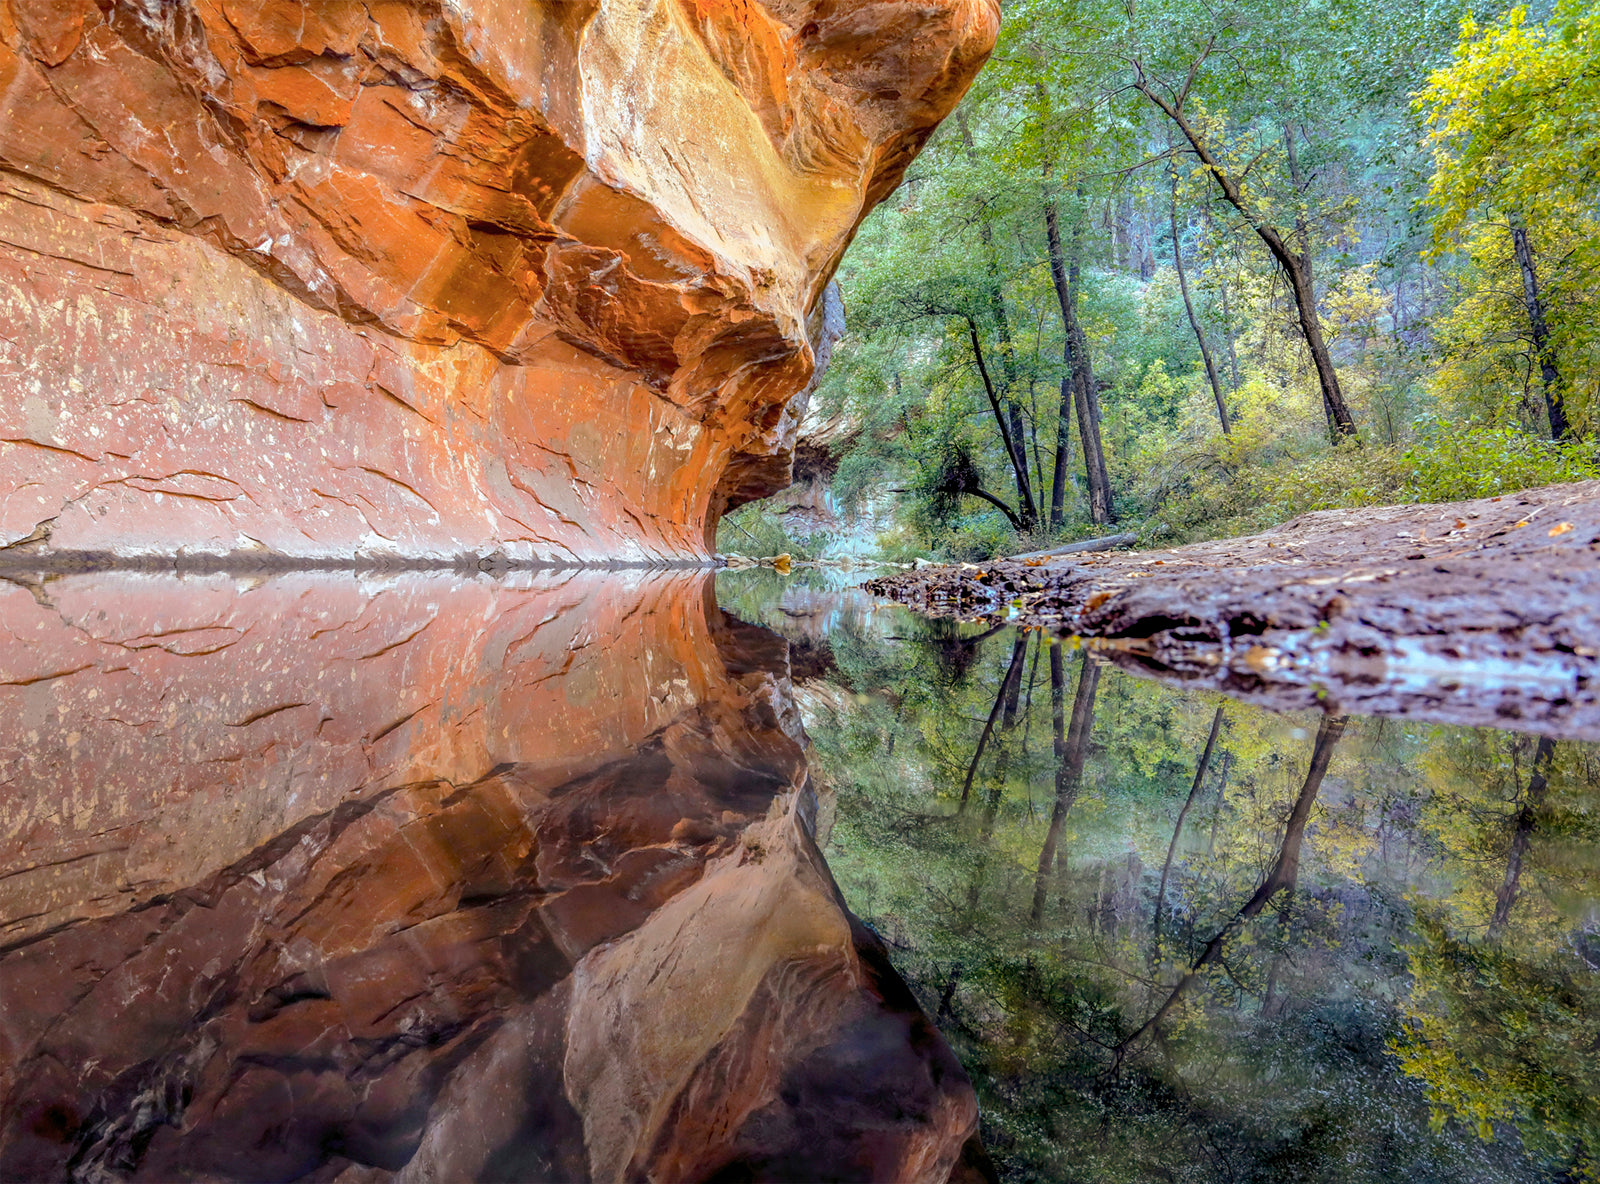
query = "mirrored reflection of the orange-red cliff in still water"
xmin=0 ymin=574 xmax=981 ymax=1181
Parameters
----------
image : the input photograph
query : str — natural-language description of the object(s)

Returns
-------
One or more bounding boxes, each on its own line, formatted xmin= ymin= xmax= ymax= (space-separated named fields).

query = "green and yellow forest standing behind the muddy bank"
xmin=722 ymin=0 xmax=1600 ymax=558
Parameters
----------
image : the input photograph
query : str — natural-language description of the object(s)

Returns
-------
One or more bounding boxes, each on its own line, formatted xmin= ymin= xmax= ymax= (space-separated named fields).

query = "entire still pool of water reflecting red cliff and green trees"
xmin=0 ymin=571 xmax=1600 ymax=1184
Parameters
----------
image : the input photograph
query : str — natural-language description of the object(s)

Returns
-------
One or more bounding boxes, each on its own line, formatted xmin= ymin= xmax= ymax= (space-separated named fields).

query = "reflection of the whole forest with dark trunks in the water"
xmin=811 ymin=624 xmax=1600 ymax=1181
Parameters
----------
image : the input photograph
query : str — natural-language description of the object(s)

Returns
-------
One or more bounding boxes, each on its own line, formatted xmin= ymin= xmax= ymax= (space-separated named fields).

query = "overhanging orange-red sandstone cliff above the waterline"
xmin=0 ymin=0 xmax=998 ymax=562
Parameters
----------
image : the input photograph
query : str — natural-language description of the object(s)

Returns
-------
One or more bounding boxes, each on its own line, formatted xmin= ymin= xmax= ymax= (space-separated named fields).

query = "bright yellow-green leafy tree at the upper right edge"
xmin=1418 ymin=0 xmax=1600 ymax=430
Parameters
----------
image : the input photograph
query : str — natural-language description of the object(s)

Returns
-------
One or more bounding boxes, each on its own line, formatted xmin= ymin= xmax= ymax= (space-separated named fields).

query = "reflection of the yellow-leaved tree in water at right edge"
xmin=1395 ymin=736 xmax=1600 ymax=1181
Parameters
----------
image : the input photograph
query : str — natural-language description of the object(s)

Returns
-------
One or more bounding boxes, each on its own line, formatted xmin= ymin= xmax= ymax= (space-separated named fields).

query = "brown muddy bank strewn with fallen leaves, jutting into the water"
xmin=867 ymin=482 xmax=1600 ymax=738
